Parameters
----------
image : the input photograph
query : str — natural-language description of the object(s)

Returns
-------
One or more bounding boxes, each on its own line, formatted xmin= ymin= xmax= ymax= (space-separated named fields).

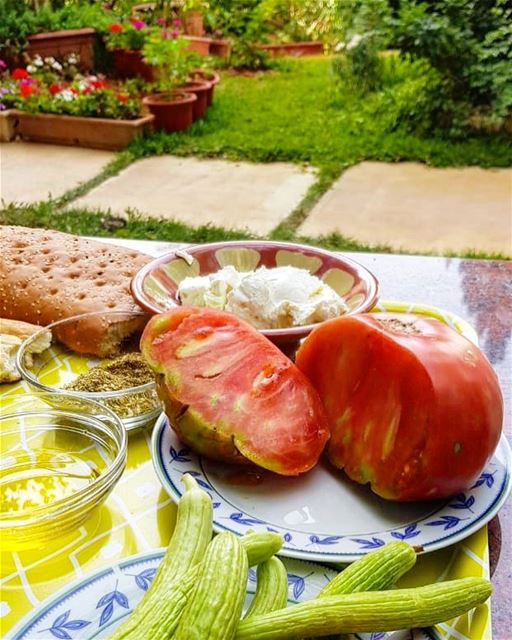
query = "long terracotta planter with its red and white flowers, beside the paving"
xmin=0 ymin=58 xmax=153 ymax=150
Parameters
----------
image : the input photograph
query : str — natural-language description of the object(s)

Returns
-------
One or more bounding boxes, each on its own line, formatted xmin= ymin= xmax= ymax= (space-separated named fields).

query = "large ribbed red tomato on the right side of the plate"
xmin=296 ymin=313 xmax=503 ymax=500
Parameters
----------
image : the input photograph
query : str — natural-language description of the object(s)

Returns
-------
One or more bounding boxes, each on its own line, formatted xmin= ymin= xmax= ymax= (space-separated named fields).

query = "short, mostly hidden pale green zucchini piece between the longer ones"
xmin=245 ymin=556 xmax=288 ymax=618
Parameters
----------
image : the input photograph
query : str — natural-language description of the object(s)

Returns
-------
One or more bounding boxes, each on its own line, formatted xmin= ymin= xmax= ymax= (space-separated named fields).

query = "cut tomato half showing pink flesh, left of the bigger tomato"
xmin=141 ymin=306 xmax=328 ymax=475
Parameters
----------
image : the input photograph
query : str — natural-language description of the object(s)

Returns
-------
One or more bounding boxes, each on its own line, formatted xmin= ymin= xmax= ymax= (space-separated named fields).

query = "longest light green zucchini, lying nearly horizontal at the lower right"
xmin=235 ymin=578 xmax=492 ymax=640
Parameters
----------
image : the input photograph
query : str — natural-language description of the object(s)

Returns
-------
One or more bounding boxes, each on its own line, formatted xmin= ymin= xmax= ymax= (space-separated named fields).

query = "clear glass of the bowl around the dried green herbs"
xmin=16 ymin=311 xmax=162 ymax=431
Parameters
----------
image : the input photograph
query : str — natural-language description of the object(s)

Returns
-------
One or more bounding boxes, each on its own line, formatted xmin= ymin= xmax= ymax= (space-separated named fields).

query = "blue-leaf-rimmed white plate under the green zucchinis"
xmin=9 ymin=550 xmax=434 ymax=640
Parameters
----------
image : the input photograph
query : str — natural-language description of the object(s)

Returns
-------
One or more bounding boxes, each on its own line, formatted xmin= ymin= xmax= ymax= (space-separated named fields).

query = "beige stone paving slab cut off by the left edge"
xmin=0 ymin=142 xmax=114 ymax=203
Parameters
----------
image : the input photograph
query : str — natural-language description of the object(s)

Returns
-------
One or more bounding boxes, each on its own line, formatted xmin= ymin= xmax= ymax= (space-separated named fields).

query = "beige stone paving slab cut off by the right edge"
xmin=298 ymin=162 xmax=512 ymax=255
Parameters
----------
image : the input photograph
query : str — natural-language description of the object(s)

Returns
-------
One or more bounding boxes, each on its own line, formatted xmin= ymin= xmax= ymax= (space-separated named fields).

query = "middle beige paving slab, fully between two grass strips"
xmin=72 ymin=156 xmax=315 ymax=235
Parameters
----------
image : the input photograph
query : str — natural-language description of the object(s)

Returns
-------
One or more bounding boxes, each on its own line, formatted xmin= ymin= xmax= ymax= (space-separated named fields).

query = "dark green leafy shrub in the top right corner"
xmin=392 ymin=0 xmax=512 ymax=135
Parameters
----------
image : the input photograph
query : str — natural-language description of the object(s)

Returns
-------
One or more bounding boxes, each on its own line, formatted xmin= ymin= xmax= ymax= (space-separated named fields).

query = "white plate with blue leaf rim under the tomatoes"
xmin=152 ymin=414 xmax=512 ymax=562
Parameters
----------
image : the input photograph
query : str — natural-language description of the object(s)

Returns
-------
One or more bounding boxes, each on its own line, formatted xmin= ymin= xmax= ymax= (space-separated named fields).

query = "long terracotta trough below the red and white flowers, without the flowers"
xmin=18 ymin=112 xmax=154 ymax=151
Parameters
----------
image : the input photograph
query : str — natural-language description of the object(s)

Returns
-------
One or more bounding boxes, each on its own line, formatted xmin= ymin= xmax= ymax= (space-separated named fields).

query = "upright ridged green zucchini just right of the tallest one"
xmin=173 ymin=533 xmax=249 ymax=640
